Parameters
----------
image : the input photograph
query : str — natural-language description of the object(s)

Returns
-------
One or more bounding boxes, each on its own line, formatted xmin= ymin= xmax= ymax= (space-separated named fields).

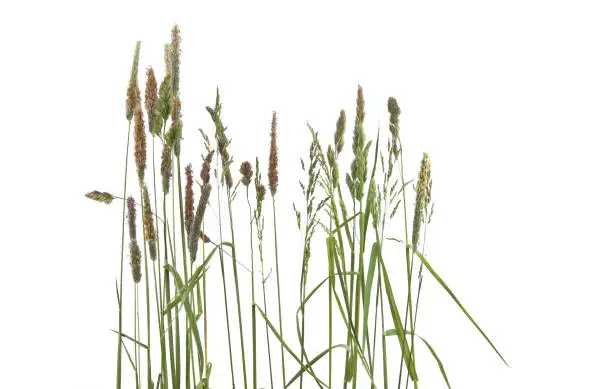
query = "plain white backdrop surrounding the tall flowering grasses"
xmin=0 ymin=0 xmax=612 ymax=389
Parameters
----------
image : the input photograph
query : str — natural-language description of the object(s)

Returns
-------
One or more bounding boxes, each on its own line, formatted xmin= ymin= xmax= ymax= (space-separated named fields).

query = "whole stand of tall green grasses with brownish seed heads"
xmin=86 ymin=26 xmax=507 ymax=389
